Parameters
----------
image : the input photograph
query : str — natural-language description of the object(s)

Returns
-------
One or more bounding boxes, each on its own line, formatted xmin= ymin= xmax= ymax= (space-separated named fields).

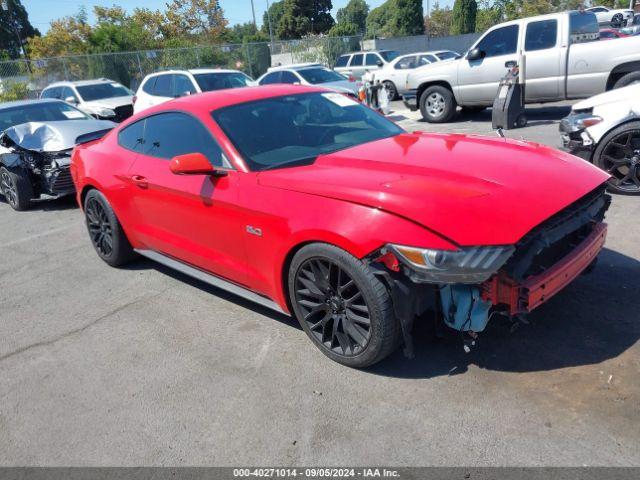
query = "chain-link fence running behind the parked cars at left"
xmin=0 ymin=36 xmax=362 ymax=97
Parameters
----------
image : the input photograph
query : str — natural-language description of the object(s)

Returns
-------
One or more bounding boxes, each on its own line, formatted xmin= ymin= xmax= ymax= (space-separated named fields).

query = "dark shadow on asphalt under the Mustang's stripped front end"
xmin=368 ymin=249 xmax=640 ymax=378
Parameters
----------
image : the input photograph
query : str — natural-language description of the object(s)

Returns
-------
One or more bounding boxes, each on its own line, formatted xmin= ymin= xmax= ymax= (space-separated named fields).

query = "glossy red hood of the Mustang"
xmin=258 ymin=134 xmax=608 ymax=245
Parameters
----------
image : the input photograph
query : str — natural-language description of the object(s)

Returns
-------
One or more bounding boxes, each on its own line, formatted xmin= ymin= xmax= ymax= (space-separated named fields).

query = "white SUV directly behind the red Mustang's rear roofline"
xmin=133 ymin=68 xmax=255 ymax=113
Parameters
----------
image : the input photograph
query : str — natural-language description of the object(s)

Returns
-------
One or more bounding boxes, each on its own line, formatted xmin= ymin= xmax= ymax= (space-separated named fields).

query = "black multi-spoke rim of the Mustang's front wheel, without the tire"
xmin=295 ymin=257 xmax=371 ymax=357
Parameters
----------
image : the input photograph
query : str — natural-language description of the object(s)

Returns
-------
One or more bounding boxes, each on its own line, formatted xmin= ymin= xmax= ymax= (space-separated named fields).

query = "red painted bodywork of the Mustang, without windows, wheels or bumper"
xmin=72 ymin=85 xmax=608 ymax=311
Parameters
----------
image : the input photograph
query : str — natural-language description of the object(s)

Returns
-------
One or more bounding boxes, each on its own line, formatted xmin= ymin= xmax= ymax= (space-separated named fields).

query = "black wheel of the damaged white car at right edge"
xmin=593 ymin=121 xmax=640 ymax=195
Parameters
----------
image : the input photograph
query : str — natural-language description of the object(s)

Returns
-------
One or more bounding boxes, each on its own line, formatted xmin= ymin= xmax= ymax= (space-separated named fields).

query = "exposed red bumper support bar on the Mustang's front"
xmin=482 ymin=223 xmax=607 ymax=315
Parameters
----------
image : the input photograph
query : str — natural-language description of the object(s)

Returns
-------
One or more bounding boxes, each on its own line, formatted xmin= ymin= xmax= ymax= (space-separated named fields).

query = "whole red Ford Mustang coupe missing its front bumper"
xmin=72 ymin=85 xmax=609 ymax=367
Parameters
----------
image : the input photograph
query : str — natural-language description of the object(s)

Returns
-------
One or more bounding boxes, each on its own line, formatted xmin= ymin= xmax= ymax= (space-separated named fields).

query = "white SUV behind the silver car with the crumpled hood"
xmin=40 ymin=78 xmax=133 ymax=122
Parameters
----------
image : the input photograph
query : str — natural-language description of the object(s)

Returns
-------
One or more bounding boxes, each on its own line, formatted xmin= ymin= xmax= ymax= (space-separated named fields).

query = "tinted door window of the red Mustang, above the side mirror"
xmin=142 ymin=112 xmax=225 ymax=167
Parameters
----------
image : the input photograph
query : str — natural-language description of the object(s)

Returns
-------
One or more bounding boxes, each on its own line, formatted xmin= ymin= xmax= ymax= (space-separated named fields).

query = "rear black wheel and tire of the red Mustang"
xmin=84 ymin=190 xmax=136 ymax=267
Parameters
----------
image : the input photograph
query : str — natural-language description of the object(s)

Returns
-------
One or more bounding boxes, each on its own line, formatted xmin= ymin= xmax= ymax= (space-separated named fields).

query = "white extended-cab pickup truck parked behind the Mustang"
xmin=399 ymin=11 xmax=640 ymax=123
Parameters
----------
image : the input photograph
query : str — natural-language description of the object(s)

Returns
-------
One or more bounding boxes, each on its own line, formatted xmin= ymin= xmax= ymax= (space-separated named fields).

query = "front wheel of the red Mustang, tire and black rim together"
xmin=288 ymin=243 xmax=400 ymax=368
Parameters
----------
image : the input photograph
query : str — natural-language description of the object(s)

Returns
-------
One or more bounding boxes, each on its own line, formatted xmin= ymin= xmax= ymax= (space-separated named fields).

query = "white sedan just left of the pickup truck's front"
xmin=363 ymin=50 xmax=460 ymax=100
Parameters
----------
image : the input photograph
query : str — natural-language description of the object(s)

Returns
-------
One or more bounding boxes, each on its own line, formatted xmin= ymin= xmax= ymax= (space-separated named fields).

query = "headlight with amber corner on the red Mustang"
xmin=387 ymin=244 xmax=515 ymax=283
